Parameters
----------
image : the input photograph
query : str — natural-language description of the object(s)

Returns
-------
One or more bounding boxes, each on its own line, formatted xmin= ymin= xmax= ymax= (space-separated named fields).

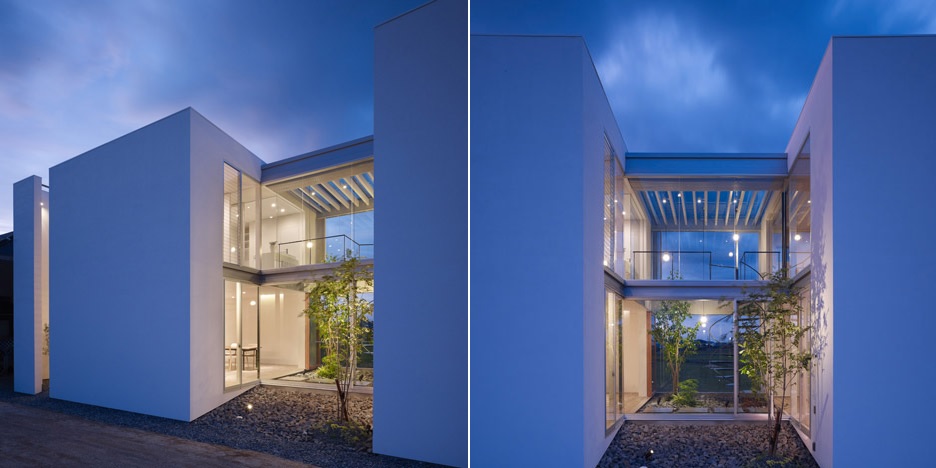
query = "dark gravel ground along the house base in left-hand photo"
xmin=0 ymin=376 xmax=438 ymax=468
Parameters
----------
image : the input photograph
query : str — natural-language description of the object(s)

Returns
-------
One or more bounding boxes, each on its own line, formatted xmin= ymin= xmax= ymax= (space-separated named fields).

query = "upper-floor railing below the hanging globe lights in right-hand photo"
xmin=630 ymin=250 xmax=780 ymax=281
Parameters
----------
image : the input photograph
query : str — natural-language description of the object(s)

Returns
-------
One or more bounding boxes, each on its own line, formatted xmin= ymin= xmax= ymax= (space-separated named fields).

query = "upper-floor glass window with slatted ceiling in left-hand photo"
xmin=260 ymin=160 xmax=376 ymax=268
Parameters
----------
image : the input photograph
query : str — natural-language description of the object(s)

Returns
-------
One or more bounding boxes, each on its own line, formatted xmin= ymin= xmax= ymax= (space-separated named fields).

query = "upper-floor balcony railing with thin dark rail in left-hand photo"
xmin=262 ymin=234 xmax=374 ymax=268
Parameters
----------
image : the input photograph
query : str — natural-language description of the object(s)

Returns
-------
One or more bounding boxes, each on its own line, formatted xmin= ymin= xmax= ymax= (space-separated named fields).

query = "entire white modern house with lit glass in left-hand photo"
xmin=14 ymin=0 xmax=468 ymax=466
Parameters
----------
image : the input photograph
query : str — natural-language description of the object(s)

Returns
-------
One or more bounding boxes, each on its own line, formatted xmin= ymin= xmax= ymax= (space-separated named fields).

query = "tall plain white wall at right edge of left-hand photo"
xmin=374 ymin=0 xmax=468 ymax=466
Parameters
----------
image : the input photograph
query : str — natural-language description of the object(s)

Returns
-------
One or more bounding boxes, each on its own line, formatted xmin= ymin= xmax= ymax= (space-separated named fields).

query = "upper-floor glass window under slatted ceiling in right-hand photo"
xmin=627 ymin=178 xmax=783 ymax=280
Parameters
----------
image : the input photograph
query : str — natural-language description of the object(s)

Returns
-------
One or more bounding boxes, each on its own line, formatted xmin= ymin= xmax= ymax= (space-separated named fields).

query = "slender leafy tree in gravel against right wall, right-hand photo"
xmin=738 ymin=270 xmax=812 ymax=456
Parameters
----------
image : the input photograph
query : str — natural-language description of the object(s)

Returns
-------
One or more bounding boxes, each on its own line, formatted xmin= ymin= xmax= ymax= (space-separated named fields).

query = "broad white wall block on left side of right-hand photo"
xmin=471 ymin=36 xmax=626 ymax=466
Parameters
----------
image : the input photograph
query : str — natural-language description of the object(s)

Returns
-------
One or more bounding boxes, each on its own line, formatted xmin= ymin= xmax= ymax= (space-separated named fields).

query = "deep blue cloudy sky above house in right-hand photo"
xmin=471 ymin=0 xmax=936 ymax=152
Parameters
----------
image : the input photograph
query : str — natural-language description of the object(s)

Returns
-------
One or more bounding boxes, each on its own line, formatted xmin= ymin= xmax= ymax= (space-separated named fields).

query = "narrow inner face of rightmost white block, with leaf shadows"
xmin=786 ymin=43 xmax=828 ymax=468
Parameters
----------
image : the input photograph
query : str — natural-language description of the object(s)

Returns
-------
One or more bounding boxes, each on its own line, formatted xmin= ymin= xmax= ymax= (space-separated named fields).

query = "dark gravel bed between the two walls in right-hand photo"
xmin=598 ymin=421 xmax=819 ymax=468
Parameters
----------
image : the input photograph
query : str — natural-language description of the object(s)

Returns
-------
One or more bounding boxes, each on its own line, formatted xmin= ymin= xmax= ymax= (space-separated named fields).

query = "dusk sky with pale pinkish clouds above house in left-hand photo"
xmin=0 ymin=0 xmax=425 ymax=233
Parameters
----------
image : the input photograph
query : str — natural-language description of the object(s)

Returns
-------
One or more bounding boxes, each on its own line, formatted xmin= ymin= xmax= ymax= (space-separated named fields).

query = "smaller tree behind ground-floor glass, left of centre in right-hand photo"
xmin=650 ymin=301 xmax=701 ymax=395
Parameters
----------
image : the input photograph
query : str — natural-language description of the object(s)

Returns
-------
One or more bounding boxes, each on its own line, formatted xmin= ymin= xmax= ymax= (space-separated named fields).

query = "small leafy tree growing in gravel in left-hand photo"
xmin=304 ymin=251 xmax=374 ymax=422
